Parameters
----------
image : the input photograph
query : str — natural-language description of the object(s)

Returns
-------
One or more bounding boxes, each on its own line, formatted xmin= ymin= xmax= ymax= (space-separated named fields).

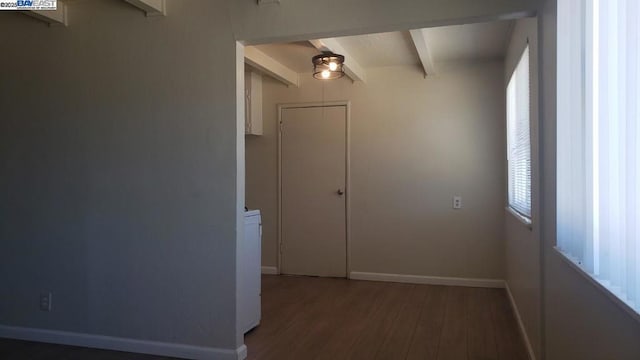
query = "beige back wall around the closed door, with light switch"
xmin=246 ymin=62 xmax=505 ymax=279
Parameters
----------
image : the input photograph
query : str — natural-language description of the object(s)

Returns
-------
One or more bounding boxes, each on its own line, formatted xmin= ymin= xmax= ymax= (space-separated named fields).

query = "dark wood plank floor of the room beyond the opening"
xmin=245 ymin=276 xmax=528 ymax=360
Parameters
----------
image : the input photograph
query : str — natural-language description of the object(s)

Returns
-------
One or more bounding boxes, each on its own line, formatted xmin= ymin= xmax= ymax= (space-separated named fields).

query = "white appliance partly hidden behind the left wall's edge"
xmin=238 ymin=210 xmax=262 ymax=333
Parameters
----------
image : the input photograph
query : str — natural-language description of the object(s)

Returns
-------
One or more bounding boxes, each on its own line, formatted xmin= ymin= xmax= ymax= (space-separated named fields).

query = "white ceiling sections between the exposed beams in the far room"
xmin=250 ymin=20 xmax=513 ymax=73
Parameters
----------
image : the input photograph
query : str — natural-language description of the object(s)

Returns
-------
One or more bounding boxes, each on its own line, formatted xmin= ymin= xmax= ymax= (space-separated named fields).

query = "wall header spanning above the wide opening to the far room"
xmin=232 ymin=0 xmax=542 ymax=44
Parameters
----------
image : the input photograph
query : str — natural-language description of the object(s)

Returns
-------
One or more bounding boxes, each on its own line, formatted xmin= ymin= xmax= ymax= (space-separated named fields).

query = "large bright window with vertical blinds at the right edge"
xmin=557 ymin=0 xmax=640 ymax=314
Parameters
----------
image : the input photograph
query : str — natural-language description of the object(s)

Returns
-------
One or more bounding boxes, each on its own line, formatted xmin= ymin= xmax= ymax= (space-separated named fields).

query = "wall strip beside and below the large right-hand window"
xmin=539 ymin=0 xmax=640 ymax=360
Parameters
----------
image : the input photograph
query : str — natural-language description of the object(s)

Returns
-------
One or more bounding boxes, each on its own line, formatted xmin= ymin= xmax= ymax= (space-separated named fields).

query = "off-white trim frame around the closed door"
xmin=276 ymin=100 xmax=351 ymax=279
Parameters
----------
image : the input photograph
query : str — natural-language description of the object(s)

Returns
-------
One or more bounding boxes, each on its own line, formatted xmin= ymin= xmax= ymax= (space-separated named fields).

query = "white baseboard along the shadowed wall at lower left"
xmin=0 ymin=325 xmax=247 ymax=360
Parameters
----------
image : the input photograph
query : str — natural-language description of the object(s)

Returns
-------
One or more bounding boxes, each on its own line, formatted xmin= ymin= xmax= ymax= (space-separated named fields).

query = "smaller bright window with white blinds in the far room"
xmin=507 ymin=46 xmax=531 ymax=218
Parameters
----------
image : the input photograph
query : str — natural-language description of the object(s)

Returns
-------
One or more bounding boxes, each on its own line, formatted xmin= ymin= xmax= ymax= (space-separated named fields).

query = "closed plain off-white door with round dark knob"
xmin=280 ymin=105 xmax=347 ymax=277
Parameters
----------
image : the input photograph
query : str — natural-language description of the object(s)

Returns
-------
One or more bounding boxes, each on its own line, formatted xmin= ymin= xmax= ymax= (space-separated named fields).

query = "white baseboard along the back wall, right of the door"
xmin=349 ymin=271 xmax=505 ymax=288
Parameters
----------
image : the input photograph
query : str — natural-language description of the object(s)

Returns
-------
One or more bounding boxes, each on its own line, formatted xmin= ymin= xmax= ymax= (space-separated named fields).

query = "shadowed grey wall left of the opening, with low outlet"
xmin=0 ymin=1 xmax=242 ymax=350
